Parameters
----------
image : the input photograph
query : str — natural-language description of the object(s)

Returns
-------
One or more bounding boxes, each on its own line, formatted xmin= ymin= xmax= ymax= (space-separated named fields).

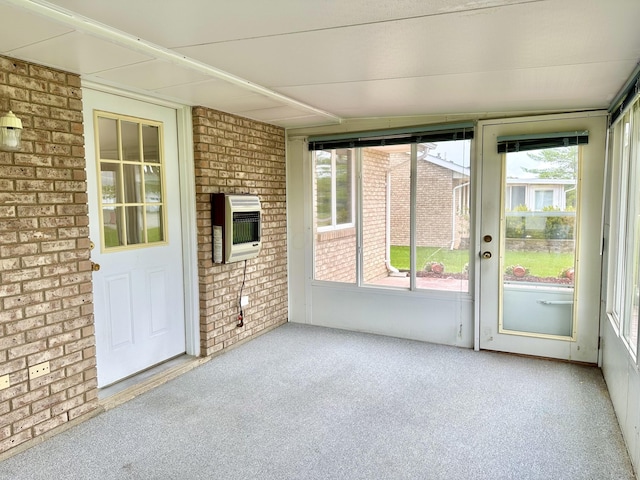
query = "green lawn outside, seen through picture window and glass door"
xmin=391 ymin=246 xmax=573 ymax=277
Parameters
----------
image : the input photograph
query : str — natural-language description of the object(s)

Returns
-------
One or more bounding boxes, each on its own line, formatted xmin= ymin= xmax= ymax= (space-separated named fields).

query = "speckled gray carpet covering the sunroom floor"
xmin=0 ymin=324 xmax=634 ymax=480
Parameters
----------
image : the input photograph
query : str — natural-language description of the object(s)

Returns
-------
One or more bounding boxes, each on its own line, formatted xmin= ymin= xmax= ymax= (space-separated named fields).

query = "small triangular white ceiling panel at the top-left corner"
xmin=0 ymin=4 xmax=72 ymax=53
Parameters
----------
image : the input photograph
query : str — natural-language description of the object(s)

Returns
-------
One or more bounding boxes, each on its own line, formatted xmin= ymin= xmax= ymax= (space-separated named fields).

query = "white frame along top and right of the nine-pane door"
xmin=82 ymin=80 xmax=200 ymax=357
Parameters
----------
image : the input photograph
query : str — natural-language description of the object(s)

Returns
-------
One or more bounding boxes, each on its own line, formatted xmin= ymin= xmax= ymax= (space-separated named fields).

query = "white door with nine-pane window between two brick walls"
xmin=83 ymin=89 xmax=185 ymax=387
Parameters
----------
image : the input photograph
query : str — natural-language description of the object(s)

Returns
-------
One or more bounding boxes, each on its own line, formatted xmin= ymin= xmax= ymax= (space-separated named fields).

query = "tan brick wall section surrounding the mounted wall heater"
xmin=193 ymin=107 xmax=288 ymax=356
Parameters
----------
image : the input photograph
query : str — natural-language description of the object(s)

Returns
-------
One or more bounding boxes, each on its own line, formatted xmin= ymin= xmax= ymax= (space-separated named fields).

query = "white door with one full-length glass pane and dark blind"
xmin=477 ymin=113 xmax=606 ymax=363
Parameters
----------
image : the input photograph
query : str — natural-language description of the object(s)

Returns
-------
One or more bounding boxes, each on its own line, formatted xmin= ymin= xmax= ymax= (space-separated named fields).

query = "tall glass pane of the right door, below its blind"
xmin=501 ymin=146 xmax=579 ymax=337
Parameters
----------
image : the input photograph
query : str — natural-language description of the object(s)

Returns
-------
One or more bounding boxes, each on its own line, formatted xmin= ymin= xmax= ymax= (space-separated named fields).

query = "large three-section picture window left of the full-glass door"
xmin=310 ymin=126 xmax=473 ymax=292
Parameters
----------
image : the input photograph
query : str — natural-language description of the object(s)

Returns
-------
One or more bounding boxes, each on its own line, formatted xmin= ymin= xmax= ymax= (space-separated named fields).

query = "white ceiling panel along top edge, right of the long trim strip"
xmin=46 ymin=0 xmax=545 ymax=48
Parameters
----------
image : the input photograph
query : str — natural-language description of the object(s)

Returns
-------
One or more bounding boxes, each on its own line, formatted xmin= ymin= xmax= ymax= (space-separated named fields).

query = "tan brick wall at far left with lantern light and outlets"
xmin=0 ymin=57 xmax=97 ymax=454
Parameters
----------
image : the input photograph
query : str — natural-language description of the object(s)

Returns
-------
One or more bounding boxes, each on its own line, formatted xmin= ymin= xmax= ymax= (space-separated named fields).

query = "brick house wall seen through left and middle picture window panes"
xmin=313 ymin=149 xmax=389 ymax=283
